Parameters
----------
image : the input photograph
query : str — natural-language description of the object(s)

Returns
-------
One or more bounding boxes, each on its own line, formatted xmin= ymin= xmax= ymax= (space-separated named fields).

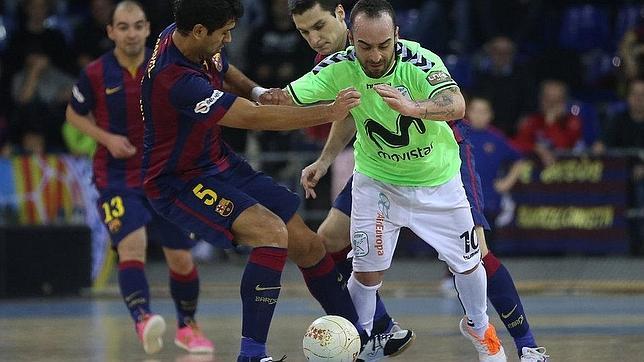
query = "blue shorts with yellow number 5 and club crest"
xmin=151 ymin=159 xmax=300 ymax=248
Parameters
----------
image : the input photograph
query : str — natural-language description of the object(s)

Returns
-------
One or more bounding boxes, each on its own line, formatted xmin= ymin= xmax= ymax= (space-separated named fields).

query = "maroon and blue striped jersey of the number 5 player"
xmin=141 ymin=24 xmax=238 ymax=198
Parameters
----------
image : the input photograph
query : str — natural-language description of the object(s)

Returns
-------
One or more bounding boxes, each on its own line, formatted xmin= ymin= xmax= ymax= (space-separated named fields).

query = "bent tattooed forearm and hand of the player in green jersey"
xmin=373 ymin=84 xmax=465 ymax=121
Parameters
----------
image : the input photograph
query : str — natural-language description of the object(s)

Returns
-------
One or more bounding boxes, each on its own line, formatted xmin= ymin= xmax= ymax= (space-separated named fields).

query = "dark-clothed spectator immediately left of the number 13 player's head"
xmin=74 ymin=0 xmax=114 ymax=69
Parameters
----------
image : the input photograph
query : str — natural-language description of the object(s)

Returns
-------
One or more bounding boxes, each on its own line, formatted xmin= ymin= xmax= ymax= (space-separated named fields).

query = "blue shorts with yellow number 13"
xmin=97 ymin=190 xmax=196 ymax=249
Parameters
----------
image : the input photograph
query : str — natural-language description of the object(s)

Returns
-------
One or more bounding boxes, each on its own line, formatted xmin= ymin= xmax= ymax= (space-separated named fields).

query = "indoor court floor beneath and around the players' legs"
xmin=0 ymin=263 xmax=644 ymax=362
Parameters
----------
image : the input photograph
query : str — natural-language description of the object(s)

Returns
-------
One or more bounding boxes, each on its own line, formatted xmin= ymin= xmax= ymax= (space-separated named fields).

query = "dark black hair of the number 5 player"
xmin=174 ymin=0 xmax=244 ymax=35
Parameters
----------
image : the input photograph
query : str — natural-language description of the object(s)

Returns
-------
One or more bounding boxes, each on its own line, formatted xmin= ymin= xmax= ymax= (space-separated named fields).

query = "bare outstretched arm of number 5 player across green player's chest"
xmin=219 ymin=88 xmax=360 ymax=131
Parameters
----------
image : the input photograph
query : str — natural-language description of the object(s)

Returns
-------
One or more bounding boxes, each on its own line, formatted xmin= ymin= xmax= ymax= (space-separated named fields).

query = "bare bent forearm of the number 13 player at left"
xmin=65 ymin=105 xmax=136 ymax=158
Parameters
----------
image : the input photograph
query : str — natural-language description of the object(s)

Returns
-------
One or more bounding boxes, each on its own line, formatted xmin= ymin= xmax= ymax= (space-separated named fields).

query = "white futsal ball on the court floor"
xmin=302 ymin=315 xmax=360 ymax=362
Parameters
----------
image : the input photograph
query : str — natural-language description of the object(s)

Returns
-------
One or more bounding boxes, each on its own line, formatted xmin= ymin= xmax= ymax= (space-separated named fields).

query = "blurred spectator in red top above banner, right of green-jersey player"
xmin=513 ymin=79 xmax=582 ymax=166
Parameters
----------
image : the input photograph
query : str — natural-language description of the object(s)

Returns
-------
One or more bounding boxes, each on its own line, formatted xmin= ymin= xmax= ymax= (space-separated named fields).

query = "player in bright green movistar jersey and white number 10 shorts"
xmin=287 ymin=0 xmax=505 ymax=361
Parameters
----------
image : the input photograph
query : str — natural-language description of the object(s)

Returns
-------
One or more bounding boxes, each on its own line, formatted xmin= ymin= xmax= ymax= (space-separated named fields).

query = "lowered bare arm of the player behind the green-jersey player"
xmin=300 ymin=116 xmax=356 ymax=199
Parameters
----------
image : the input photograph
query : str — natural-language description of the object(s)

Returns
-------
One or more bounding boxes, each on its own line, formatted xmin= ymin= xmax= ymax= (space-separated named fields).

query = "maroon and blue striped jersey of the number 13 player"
xmin=70 ymin=51 xmax=151 ymax=190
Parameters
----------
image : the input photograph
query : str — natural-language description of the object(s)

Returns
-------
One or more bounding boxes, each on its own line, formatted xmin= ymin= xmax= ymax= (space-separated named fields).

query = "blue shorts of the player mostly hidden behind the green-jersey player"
xmin=333 ymin=140 xmax=490 ymax=230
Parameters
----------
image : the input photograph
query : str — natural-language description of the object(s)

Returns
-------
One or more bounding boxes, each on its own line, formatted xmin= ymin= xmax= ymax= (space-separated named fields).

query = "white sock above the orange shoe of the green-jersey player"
xmin=454 ymin=263 xmax=489 ymax=338
